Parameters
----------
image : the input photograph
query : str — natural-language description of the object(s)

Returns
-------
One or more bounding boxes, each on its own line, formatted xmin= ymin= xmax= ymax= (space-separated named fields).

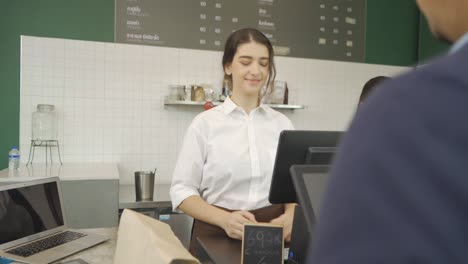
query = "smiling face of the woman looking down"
xmin=224 ymin=41 xmax=269 ymax=96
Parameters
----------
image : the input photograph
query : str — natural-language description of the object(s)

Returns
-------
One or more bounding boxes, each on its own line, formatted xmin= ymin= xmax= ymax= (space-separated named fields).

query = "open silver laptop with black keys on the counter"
xmin=0 ymin=177 xmax=108 ymax=263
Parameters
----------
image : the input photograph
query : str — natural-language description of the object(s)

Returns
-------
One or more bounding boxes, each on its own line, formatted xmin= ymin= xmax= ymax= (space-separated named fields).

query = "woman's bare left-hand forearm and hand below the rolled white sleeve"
xmin=179 ymin=195 xmax=257 ymax=239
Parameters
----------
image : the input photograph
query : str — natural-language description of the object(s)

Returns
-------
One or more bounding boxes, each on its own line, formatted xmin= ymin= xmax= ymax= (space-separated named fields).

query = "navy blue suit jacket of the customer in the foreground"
xmin=309 ymin=45 xmax=468 ymax=264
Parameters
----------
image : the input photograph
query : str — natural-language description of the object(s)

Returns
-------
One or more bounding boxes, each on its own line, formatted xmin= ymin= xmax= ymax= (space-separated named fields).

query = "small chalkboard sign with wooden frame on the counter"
xmin=242 ymin=224 xmax=284 ymax=264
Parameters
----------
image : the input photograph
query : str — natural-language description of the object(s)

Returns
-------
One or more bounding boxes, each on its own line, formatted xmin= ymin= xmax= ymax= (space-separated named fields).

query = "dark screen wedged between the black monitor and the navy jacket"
xmin=290 ymin=165 xmax=330 ymax=263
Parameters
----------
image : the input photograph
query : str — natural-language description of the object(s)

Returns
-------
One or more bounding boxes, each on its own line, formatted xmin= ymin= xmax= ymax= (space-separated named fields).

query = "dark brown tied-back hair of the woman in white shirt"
xmin=222 ymin=28 xmax=276 ymax=96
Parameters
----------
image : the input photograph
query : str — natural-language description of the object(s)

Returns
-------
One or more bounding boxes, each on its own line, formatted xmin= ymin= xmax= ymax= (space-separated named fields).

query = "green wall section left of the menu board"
xmin=0 ymin=0 xmax=114 ymax=169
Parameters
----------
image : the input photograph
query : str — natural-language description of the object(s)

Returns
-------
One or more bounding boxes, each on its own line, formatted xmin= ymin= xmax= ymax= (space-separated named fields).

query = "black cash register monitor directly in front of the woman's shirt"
xmin=268 ymin=130 xmax=342 ymax=204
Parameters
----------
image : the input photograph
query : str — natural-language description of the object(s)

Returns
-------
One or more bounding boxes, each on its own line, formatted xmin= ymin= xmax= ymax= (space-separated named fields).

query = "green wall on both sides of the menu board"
xmin=0 ymin=0 xmax=445 ymax=169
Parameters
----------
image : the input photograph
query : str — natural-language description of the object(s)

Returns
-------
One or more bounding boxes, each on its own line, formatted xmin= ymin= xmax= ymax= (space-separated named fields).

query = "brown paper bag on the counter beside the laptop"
xmin=114 ymin=209 xmax=200 ymax=264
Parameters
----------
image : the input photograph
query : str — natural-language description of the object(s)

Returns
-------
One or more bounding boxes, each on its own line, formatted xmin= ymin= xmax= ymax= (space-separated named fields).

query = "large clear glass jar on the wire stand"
xmin=32 ymin=104 xmax=57 ymax=140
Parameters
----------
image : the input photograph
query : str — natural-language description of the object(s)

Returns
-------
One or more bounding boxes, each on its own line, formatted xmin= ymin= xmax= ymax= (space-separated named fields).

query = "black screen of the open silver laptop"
xmin=0 ymin=182 xmax=64 ymax=244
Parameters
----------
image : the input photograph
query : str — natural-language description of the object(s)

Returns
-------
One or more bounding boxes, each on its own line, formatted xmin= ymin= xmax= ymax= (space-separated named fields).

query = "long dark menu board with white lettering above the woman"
xmin=115 ymin=0 xmax=366 ymax=62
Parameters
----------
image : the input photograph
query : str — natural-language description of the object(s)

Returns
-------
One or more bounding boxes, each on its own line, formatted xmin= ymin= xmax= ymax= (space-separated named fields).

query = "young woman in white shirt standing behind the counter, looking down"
xmin=170 ymin=28 xmax=294 ymax=254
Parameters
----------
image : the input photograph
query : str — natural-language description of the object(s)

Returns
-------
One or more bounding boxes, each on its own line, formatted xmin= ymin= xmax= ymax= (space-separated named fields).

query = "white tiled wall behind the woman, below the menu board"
xmin=20 ymin=36 xmax=407 ymax=183
